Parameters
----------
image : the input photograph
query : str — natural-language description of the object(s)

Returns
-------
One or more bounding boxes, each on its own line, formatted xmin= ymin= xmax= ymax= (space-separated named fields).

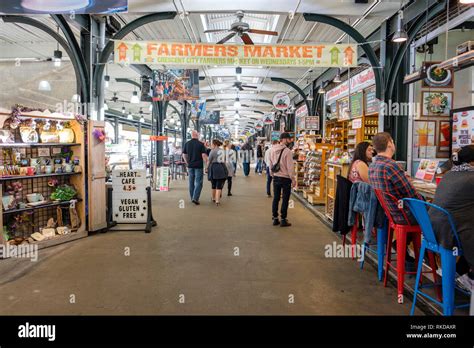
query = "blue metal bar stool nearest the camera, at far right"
xmin=403 ymin=198 xmax=470 ymax=315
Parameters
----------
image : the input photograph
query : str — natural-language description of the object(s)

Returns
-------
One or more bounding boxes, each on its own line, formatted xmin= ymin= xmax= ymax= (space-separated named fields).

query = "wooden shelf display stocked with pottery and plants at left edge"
xmin=0 ymin=108 xmax=87 ymax=247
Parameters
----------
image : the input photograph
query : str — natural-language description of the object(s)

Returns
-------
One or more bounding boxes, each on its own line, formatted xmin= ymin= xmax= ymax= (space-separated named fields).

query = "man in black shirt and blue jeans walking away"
xmin=183 ymin=130 xmax=207 ymax=205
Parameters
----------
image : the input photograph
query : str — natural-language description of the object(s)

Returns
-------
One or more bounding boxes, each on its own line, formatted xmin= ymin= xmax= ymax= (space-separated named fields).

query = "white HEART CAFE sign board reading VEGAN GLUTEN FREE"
xmin=112 ymin=169 xmax=148 ymax=223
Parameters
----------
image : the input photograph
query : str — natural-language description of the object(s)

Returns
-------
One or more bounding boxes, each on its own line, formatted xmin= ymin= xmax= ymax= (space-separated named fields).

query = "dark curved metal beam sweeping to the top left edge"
xmin=0 ymin=16 xmax=88 ymax=104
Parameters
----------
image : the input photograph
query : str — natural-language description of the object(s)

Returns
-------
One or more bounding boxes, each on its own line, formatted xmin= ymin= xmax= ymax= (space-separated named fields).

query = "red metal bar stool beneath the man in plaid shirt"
xmin=375 ymin=189 xmax=441 ymax=303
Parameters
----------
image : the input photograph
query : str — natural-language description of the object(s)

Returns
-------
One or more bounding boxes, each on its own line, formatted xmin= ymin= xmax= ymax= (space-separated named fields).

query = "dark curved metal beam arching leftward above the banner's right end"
xmin=303 ymin=13 xmax=383 ymax=100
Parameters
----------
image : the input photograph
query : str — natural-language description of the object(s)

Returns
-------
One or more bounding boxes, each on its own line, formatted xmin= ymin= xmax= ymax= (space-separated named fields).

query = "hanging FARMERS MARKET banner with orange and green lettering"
xmin=114 ymin=41 xmax=357 ymax=67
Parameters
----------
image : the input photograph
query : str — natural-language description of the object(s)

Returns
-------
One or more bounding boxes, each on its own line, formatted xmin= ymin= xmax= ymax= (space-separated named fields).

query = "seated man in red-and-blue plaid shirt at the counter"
xmin=369 ymin=132 xmax=423 ymax=224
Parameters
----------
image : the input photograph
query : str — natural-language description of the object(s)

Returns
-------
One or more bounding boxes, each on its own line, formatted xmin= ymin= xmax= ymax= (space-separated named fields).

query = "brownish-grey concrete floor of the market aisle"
xmin=0 ymin=172 xmax=422 ymax=315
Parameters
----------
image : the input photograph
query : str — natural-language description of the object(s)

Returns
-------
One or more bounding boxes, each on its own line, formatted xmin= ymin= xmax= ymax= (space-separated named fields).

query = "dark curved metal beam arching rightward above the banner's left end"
xmin=93 ymin=12 xmax=176 ymax=96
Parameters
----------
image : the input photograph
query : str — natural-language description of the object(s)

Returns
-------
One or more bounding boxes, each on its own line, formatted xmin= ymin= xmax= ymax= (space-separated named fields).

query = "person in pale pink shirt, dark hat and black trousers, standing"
xmin=268 ymin=133 xmax=296 ymax=227
